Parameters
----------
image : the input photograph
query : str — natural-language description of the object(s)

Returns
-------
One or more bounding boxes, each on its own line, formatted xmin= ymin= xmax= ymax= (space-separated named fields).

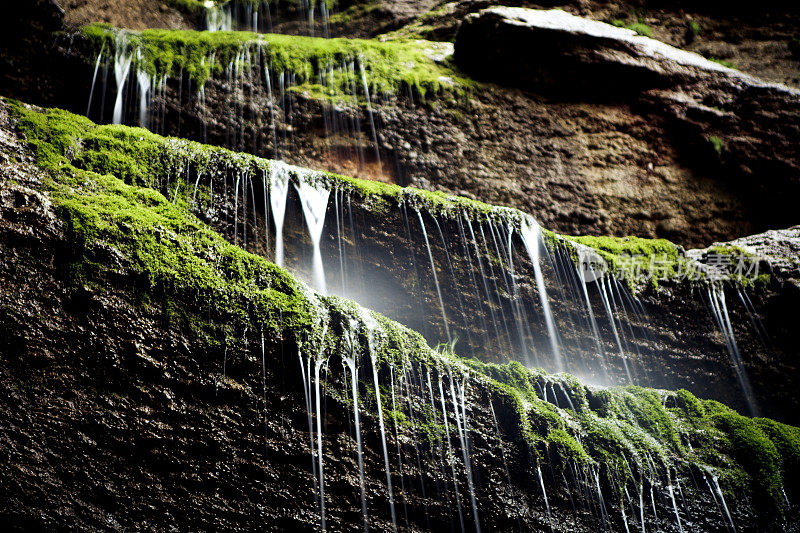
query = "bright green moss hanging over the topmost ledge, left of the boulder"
xmin=81 ymin=24 xmax=472 ymax=98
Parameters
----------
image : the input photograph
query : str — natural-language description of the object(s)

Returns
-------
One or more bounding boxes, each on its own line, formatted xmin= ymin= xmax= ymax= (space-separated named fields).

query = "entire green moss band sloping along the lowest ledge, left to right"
xmin=3 ymin=94 xmax=800 ymax=513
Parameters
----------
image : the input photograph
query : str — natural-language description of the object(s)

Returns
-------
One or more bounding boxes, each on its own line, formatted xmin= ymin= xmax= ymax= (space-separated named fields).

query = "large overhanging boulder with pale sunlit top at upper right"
xmin=456 ymin=8 xmax=800 ymax=247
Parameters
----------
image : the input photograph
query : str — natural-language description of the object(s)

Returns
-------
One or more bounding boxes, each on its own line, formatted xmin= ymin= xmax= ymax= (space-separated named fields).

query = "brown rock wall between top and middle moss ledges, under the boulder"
xmin=0 ymin=5 xmax=796 ymax=246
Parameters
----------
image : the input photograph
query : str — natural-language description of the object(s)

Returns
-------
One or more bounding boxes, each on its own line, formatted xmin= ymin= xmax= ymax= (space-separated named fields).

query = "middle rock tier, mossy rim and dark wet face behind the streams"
xmin=7 ymin=97 xmax=800 ymax=421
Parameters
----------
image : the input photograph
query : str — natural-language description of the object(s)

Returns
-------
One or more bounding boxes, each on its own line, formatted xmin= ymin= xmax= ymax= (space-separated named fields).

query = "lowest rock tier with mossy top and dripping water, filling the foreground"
xmin=0 ymin=95 xmax=800 ymax=532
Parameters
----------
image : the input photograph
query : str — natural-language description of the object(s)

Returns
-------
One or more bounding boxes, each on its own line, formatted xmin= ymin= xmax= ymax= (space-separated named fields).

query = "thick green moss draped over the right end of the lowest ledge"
xmin=465 ymin=352 xmax=800 ymax=506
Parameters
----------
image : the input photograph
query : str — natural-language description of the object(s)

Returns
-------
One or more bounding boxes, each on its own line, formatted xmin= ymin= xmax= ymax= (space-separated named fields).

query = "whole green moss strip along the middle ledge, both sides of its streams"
xmin=10 ymin=96 xmax=770 ymax=300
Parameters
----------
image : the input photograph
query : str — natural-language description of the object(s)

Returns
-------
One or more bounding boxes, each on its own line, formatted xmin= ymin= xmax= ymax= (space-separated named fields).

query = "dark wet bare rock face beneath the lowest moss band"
xmin=0 ymin=102 xmax=792 ymax=532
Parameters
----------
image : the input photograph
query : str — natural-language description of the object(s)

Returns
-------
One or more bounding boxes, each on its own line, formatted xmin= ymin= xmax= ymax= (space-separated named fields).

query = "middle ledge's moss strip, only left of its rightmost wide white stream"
xmin=9 ymin=98 xmax=524 ymax=224
